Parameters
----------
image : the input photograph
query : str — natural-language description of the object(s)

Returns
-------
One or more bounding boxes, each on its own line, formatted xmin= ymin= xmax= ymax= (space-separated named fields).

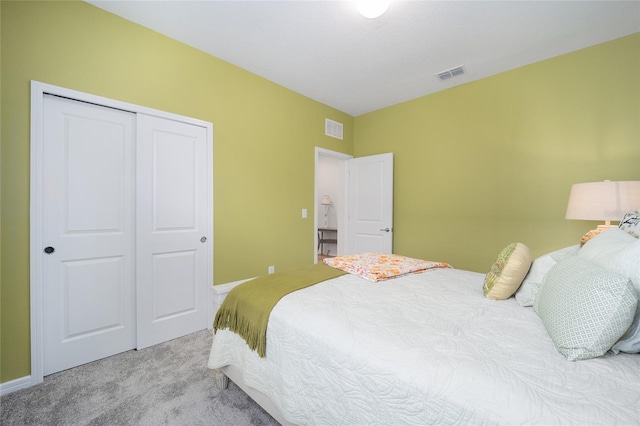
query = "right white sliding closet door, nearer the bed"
xmin=136 ymin=114 xmax=212 ymax=349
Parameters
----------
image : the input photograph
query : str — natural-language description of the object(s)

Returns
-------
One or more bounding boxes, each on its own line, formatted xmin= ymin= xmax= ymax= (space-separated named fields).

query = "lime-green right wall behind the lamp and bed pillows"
xmin=354 ymin=34 xmax=640 ymax=272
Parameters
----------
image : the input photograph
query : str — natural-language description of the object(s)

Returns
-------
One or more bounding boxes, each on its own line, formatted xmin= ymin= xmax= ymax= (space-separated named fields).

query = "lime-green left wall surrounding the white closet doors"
xmin=0 ymin=1 xmax=353 ymax=382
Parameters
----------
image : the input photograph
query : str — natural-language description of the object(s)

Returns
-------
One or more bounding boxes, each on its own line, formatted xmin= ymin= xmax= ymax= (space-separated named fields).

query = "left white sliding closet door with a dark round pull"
xmin=40 ymin=95 xmax=136 ymax=375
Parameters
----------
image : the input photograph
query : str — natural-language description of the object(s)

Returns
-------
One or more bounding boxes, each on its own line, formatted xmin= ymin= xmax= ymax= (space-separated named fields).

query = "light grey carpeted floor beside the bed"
xmin=0 ymin=330 xmax=278 ymax=426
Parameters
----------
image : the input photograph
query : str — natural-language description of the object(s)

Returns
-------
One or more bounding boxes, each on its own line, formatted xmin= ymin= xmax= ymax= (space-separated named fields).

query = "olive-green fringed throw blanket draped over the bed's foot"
xmin=213 ymin=263 xmax=346 ymax=358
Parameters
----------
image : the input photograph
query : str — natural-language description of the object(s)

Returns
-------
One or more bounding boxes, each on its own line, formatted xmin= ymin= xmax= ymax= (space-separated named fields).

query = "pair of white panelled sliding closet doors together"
xmin=37 ymin=90 xmax=213 ymax=376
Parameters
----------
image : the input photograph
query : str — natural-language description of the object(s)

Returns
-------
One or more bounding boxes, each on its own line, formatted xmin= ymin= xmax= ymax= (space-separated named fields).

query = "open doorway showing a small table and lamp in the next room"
xmin=314 ymin=147 xmax=353 ymax=262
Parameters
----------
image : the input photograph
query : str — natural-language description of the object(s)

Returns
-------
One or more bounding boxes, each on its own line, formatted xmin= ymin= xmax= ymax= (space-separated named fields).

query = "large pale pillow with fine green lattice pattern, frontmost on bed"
xmin=534 ymin=256 xmax=638 ymax=361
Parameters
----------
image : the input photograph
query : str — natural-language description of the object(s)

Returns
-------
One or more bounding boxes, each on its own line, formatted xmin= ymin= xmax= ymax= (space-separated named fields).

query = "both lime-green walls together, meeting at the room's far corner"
xmin=0 ymin=1 xmax=640 ymax=382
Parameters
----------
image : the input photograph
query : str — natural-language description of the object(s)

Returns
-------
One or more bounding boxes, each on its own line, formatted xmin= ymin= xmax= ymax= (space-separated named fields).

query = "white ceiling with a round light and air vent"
xmin=86 ymin=0 xmax=640 ymax=116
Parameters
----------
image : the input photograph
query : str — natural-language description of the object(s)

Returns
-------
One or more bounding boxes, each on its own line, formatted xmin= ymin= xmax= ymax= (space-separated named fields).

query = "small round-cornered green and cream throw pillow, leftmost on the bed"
xmin=482 ymin=243 xmax=531 ymax=300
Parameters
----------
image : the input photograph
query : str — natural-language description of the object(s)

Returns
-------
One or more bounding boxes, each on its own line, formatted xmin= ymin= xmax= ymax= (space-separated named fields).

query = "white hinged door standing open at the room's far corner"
xmin=346 ymin=153 xmax=393 ymax=254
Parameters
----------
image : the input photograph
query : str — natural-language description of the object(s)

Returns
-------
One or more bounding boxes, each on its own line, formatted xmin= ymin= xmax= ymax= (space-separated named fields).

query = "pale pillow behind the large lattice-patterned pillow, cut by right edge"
xmin=578 ymin=228 xmax=640 ymax=353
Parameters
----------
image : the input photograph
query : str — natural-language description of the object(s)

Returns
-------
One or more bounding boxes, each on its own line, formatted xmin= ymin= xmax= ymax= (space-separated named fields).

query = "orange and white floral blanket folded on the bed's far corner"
xmin=324 ymin=253 xmax=451 ymax=283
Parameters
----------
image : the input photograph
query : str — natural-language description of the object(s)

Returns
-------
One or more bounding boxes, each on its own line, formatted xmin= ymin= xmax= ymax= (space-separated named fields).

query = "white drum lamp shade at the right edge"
xmin=565 ymin=181 xmax=640 ymax=221
